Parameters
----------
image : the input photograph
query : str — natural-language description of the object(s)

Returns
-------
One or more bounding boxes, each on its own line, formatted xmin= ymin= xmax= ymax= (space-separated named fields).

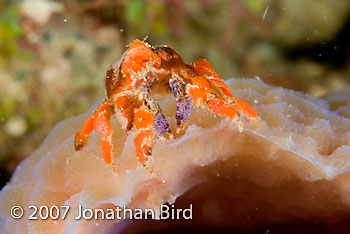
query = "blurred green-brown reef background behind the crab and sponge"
xmin=0 ymin=0 xmax=350 ymax=198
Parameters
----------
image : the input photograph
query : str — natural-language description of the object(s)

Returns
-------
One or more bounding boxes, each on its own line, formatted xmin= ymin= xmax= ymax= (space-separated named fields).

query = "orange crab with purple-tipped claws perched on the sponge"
xmin=74 ymin=40 xmax=257 ymax=166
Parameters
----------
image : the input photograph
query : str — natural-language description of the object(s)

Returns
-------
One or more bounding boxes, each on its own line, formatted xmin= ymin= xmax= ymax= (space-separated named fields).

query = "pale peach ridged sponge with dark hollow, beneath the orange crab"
xmin=0 ymin=79 xmax=350 ymax=233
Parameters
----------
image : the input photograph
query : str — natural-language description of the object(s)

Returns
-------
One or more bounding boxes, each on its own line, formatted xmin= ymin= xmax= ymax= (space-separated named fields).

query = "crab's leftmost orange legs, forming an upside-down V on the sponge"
xmin=74 ymin=100 xmax=113 ymax=164
